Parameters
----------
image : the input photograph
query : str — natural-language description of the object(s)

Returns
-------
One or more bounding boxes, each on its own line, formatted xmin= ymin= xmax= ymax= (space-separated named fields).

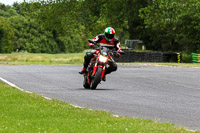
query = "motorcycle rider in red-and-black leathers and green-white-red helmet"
xmin=79 ymin=27 xmax=121 ymax=81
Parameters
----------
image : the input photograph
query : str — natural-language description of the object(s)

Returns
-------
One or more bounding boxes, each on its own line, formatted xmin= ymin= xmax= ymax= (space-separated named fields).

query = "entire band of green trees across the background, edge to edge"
xmin=0 ymin=0 xmax=200 ymax=53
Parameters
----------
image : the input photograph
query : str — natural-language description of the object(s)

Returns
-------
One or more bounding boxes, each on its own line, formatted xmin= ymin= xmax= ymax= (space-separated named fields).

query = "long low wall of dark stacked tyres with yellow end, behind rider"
xmin=114 ymin=50 xmax=182 ymax=63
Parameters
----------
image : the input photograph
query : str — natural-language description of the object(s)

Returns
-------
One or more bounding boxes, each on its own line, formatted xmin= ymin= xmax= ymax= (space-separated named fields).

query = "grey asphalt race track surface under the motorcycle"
xmin=0 ymin=65 xmax=200 ymax=130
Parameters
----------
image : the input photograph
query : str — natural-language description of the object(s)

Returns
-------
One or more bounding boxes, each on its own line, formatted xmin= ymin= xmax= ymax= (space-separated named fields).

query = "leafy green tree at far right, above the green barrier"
xmin=140 ymin=0 xmax=200 ymax=52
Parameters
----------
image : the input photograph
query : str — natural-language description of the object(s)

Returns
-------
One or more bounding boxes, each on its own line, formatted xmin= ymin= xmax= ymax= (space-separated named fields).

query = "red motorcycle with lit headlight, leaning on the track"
xmin=83 ymin=40 xmax=124 ymax=90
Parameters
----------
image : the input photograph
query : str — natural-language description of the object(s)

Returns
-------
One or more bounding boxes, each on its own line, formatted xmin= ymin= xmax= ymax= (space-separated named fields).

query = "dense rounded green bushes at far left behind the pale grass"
xmin=0 ymin=3 xmax=83 ymax=53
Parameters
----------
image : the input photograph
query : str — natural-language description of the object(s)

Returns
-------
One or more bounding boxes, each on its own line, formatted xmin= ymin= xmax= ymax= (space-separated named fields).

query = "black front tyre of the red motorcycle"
xmin=90 ymin=67 xmax=103 ymax=90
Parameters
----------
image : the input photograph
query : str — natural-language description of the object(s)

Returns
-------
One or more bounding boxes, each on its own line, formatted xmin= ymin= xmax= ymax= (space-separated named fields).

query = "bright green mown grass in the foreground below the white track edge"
xmin=0 ymin=82 xmax=199 ymax=133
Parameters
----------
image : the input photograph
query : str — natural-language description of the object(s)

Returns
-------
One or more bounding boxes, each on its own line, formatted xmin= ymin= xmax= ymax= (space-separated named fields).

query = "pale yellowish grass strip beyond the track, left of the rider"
xmin=0 ymin=52 xmax=85 ymax=64
